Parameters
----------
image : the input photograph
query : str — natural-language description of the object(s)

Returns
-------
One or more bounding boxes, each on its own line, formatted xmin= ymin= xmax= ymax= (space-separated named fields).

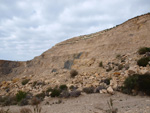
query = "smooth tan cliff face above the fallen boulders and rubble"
xmin=0 ymin=14 xmax=150 ymax=80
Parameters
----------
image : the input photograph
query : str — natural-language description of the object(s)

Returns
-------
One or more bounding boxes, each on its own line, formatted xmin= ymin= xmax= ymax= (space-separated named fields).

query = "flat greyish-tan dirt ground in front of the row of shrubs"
xmin=1 ymin=92 xmax=150 ymax=113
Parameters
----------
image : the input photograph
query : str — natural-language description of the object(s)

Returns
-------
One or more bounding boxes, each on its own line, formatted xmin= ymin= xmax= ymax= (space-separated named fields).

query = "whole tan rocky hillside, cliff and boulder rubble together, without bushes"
xmin=0 ymin=13 xmax=150 ymax=94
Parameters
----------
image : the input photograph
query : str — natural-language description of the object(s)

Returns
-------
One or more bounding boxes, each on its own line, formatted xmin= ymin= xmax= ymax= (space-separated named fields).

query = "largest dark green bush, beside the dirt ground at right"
xmin=122 ymin=74 xmax=150 ymax=95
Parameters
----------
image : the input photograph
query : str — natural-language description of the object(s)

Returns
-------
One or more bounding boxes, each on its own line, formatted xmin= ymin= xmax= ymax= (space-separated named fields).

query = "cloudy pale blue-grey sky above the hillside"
xmin=0 ymin=0 xmax=150 ymax=61
